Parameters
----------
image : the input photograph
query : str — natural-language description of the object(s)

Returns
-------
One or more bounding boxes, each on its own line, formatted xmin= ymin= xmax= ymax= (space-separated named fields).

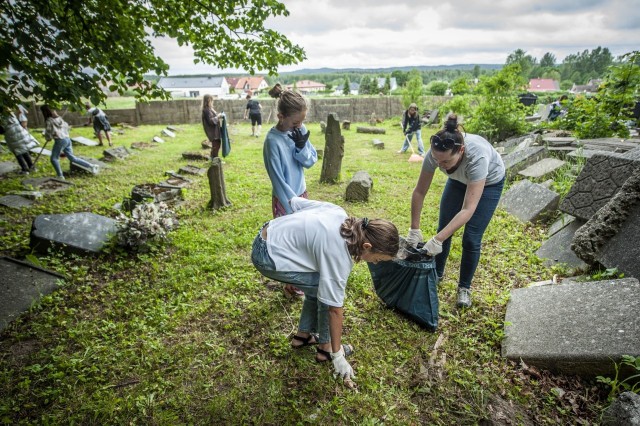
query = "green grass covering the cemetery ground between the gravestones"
xmin=0 ymin=120 xmax=606 ymax=425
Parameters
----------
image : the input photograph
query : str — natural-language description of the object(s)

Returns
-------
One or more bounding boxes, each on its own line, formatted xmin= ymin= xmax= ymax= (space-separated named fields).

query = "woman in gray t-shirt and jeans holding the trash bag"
xmin=407 ymin=114 xmax=505 ymax=308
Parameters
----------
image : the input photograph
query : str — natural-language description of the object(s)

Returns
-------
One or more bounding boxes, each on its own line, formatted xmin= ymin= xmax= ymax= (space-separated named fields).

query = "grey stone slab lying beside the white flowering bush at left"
xmin=30 ymin=212 xmax=118 ymax=254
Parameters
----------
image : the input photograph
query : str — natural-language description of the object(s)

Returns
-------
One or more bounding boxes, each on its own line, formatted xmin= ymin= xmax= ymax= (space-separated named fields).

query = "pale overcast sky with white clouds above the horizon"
xmin=154 ymin=0 xmax=640 ymax=75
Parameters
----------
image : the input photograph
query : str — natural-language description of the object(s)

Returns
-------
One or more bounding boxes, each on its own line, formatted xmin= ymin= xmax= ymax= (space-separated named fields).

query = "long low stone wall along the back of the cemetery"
xmin=28 ymin=96 xmax=448 ymax=128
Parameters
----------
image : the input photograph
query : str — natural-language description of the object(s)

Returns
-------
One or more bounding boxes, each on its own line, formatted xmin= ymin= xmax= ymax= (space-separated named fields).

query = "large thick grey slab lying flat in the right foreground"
xmin=502 ymin=278 xmax=640 ymax=376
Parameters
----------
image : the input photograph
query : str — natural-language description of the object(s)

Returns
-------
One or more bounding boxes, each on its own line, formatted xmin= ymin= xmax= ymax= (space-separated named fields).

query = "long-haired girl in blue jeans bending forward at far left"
xmin=40 ymin=105 xmax=99 ymax=179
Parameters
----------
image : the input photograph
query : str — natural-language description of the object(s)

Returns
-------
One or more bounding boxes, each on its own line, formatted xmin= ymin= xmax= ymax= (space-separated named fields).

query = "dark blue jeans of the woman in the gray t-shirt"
xmin=436 ymin=178 xmax=504 ymax=288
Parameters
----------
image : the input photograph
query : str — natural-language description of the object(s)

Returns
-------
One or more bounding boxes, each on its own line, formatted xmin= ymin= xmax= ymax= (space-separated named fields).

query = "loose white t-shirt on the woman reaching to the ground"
xmin=267 ymin=197 xmax=353 ymax=307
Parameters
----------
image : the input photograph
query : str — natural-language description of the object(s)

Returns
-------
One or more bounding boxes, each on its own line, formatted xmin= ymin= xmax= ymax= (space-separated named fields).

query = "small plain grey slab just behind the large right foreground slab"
xmin=536 ymin=221 xmax=589 ymax=274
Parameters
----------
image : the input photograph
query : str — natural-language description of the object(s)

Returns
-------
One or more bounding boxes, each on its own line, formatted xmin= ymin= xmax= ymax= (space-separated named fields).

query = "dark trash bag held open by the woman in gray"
xmin=367 ymin=239 xmax=438 ymax=331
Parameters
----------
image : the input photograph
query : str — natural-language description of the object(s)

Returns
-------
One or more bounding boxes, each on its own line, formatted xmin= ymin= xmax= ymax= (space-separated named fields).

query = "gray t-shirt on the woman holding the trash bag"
xmin=422 ymin=133 xmax=504 ymax=185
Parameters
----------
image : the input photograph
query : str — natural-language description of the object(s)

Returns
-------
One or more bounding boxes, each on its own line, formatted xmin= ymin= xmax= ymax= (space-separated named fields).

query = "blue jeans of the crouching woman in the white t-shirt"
xmin=251 ymin=230 xmax=331 ymax=343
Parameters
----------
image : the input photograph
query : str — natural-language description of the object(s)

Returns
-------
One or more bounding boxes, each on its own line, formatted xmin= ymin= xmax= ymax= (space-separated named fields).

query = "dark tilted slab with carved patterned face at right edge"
xmin=560 ymin=153 xmax=640 ymax=221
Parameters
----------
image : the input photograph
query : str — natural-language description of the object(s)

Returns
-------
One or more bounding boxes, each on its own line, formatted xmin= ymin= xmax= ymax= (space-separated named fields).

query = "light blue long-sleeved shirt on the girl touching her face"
xmin=262 ymin=125 xmax=318 ymax=214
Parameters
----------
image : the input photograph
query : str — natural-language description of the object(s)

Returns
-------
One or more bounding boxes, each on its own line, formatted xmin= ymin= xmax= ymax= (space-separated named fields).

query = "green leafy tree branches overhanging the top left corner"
xmin=0 ymin=0 xmax=305 ymax=107
